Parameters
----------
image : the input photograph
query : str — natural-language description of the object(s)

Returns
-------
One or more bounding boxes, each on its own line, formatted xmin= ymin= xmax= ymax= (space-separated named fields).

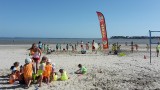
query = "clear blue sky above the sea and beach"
xmin=0 ymin=0 xmax=160 ymax=38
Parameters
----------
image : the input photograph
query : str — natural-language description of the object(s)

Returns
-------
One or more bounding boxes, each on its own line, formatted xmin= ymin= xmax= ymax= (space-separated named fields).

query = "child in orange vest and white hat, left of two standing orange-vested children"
xmin=23 ymin=58 xmax=33 ymax=89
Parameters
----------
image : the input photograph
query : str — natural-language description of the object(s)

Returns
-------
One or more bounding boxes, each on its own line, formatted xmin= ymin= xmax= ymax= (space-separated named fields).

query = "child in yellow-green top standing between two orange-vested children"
xmin=37 ymin=56 xmax=47 ymax=87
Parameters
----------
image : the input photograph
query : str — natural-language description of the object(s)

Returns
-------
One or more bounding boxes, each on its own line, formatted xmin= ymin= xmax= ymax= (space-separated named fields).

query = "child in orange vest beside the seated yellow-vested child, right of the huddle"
xmin=43 ymin=59 xmax=52 ymax=84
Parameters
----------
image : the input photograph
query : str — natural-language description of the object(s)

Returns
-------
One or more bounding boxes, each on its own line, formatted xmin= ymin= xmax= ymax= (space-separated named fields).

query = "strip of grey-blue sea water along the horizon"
xmin=0 ymin=38 xmax=160 ymax=45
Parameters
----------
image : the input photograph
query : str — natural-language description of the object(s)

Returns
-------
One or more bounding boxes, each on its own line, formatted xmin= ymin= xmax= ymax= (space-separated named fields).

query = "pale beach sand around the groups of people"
xmin=0 ymin=45 xmax=160 ymax=90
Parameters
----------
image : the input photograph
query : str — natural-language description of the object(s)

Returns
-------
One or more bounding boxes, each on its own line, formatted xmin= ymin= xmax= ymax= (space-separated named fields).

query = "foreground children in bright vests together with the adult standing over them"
xmin=9 ymin=42 xmax=87 ymax=89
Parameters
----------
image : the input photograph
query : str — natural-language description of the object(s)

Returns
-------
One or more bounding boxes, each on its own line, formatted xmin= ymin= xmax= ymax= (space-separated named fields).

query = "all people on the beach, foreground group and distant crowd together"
xmin=6 ymin=40 xmax=160 ymax=88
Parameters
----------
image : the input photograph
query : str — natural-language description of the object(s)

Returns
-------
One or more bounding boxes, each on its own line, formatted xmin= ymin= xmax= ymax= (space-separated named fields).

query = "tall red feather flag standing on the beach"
xmin=97 ymin=12 xmax=109 ymax=49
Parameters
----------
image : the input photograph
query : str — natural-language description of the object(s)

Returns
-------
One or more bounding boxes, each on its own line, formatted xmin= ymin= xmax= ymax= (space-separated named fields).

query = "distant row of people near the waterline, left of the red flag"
xmin=38 ymin=40 xmax=102 ymax=54
